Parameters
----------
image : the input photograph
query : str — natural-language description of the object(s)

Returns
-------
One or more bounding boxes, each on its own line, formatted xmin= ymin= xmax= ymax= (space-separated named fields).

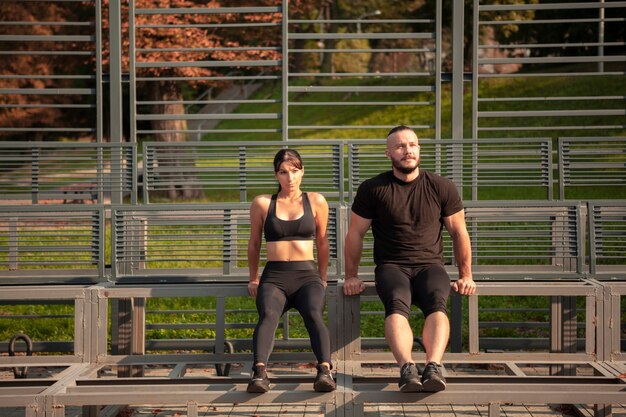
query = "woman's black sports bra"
xmin=263 ymin=193 xmax=315 ymax=242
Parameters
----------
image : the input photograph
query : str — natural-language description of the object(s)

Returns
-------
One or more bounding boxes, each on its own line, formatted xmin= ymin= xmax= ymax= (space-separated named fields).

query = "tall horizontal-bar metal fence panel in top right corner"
xmin=472 ymin=0 xmax=626 ymax=138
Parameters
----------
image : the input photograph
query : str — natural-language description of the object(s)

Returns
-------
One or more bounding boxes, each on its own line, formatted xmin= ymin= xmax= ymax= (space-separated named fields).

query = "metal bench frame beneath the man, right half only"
xmin=336 ymin=280 xmax=626 ymax=417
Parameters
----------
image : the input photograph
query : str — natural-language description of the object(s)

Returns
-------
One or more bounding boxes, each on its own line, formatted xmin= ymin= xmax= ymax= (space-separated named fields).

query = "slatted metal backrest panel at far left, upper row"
xmin=0 ymin=142 xmax=137 ymax=204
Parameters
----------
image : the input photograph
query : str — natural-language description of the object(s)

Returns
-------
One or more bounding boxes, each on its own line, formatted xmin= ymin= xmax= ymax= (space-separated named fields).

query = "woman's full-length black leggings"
xmin=252 ymin=261 xmax=331 ymax=364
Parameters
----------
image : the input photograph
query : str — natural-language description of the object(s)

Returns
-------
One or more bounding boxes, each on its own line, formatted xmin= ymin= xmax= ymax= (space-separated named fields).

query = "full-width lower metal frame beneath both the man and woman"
xmin=0 ymin=280 xmax=625 ymax=417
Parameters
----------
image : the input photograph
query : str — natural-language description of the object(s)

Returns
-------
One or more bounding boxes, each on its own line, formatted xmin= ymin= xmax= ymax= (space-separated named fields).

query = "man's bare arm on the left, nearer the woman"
xmin=343 ymin=212 xmax=372 ymax=295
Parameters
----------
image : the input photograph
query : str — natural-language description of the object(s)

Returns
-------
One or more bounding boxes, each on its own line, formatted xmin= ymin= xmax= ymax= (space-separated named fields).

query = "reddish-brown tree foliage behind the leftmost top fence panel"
xmin=0 ymin=2 xmax=93 ymax=140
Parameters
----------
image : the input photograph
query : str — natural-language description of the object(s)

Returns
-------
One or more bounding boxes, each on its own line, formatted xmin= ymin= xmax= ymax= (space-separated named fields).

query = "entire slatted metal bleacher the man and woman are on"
xmin=0 ymin=139 xmax=626 ymax=417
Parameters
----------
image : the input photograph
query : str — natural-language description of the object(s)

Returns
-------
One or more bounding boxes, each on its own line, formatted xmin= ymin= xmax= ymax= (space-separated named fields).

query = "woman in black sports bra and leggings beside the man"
xmin=247 ymin=149 xmax=336 ymax=393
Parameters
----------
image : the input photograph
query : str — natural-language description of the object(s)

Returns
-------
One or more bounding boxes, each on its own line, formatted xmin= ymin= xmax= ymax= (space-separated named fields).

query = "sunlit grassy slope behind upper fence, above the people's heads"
xmin=204 ymin=72 xmax=626 ymax=141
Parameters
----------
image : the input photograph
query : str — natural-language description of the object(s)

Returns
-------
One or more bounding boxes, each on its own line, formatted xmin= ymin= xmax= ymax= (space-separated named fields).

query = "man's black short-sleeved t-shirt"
xmin=352 ymin=170 xmax=463 ymax=265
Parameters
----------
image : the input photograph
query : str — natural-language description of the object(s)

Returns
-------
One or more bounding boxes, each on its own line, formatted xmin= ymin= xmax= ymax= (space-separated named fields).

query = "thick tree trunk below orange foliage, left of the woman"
xmin=152 ymin=81 xmax=204 ymax=200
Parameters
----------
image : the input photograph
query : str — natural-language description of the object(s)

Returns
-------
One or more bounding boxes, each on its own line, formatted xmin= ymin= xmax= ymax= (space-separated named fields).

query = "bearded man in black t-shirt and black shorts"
xmin=344 ymin=126 xmax=476 ymax=392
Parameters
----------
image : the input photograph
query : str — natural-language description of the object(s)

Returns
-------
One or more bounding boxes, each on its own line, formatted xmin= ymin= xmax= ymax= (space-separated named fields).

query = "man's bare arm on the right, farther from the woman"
xmin=443 ymin=210 xmax=476 ymax=295
